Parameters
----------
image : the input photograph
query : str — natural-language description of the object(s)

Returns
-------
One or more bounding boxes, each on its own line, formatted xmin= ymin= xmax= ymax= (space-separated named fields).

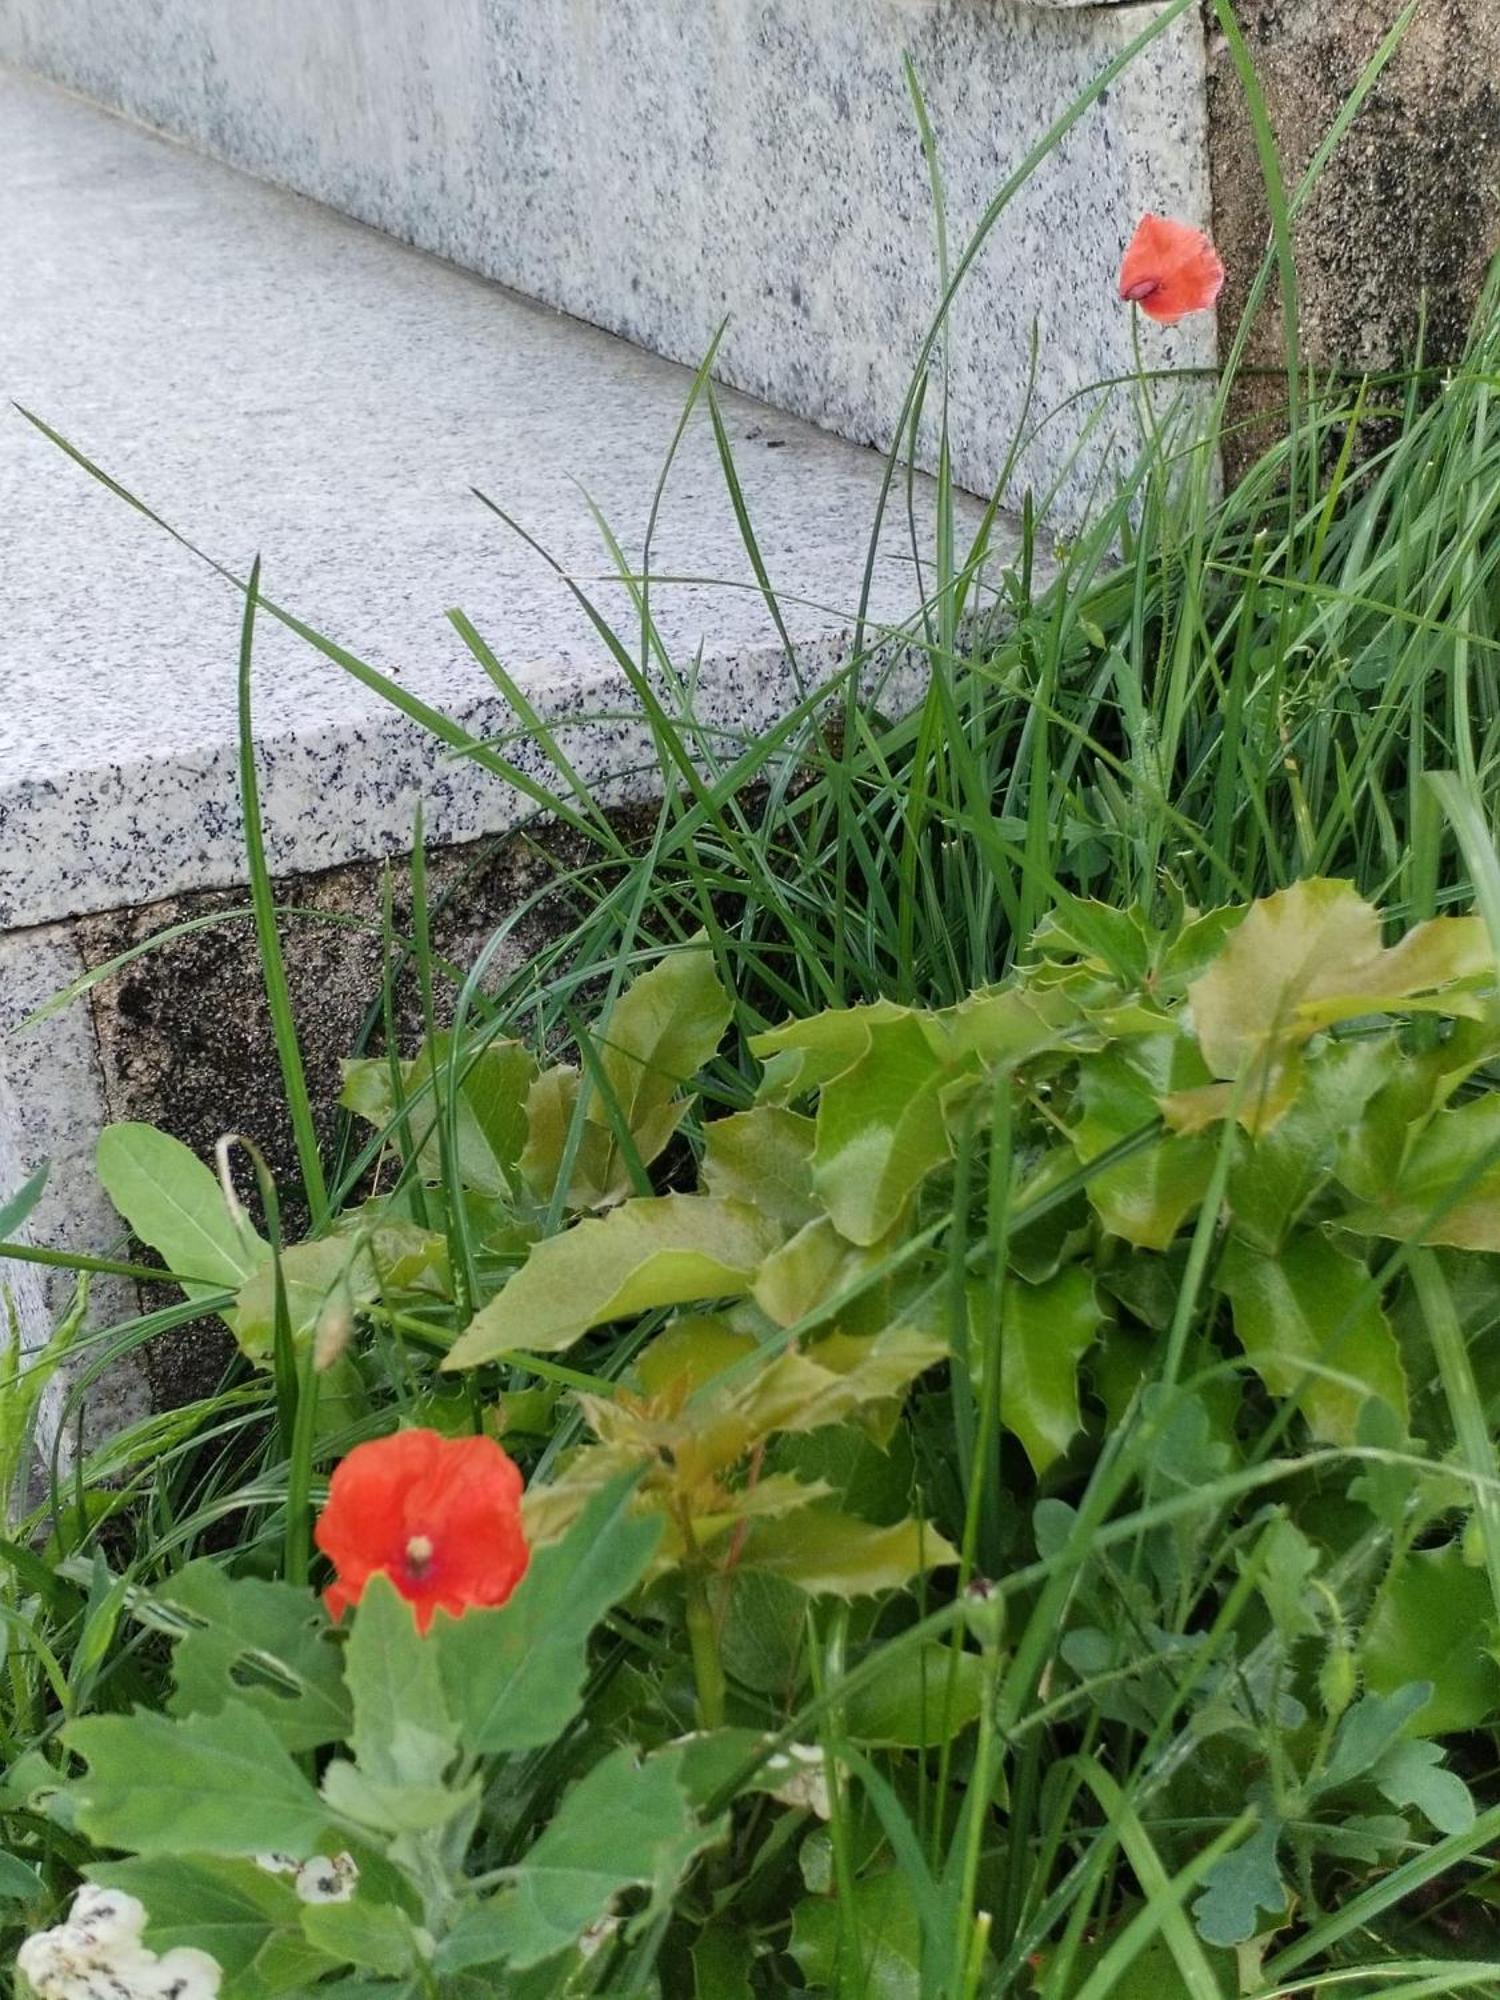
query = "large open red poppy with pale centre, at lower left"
xmin=318 ymin=1430 xmax=530 ymax=1632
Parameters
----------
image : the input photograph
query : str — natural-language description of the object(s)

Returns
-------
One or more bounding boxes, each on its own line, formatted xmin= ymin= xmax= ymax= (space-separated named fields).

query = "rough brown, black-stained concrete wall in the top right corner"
xmin=1204 ymin=0 xmax=1500 ymax=460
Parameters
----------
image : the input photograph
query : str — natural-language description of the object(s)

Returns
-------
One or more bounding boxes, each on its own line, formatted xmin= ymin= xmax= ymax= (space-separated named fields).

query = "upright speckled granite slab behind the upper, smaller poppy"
xmin=0 ymin=0 xmax=1212 ymax=514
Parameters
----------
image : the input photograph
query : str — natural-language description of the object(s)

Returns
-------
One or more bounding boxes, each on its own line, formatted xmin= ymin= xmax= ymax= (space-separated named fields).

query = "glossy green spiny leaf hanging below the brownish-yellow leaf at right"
xmin=1218 ymin=1230 xmax=1406 ymax=1444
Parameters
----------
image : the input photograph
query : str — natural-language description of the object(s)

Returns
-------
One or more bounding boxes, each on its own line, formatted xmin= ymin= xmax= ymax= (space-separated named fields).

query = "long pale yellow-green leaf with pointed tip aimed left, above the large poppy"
xmin=442 ymin=1194 xmax=774 ymax=1368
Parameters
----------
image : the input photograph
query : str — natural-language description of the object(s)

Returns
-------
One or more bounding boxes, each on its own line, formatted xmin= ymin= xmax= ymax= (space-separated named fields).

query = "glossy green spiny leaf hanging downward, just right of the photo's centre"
xmin=812 ymin=1014 xmax=952 ymax=1244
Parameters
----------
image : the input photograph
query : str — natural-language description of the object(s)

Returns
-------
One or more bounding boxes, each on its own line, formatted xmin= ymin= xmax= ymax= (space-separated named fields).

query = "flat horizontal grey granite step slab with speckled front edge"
xmin=0 ymin=68 xmax=1010 ymax=930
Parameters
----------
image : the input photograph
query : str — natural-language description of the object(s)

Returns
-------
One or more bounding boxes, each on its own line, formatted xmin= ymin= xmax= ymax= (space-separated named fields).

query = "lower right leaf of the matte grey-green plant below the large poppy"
xmin=462 ymin=1748 xmax=714 ymax=1972
